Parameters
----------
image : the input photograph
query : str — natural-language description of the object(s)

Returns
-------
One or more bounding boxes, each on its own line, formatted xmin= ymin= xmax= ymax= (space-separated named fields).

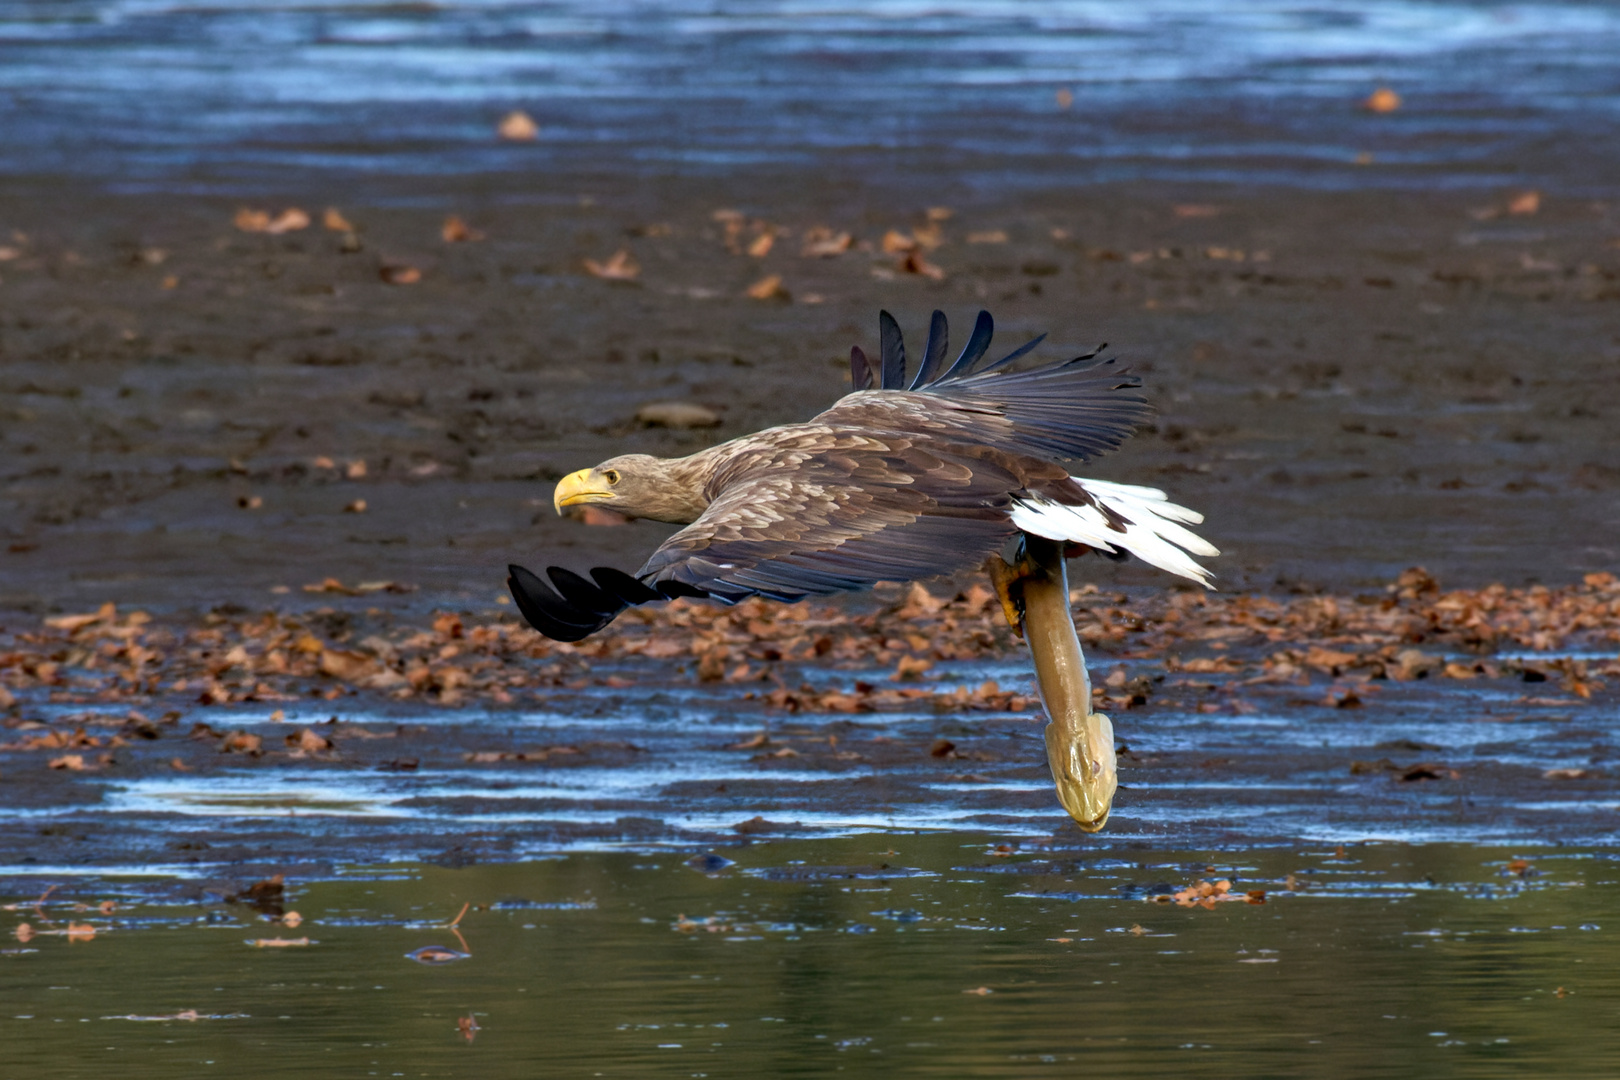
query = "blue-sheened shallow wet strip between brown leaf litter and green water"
xmin=12 ymin=641 xmax=1620 ymax=881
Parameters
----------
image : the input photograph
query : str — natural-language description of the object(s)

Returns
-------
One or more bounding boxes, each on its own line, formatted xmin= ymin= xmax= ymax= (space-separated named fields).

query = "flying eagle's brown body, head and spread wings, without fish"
xmin=509 ymin=311 xmax=1192 ymax=641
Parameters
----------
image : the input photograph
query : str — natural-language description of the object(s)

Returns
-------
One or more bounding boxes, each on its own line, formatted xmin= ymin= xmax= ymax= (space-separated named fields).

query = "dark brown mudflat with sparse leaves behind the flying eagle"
xmin=0 ymin=181 xmax=1620 ymax=615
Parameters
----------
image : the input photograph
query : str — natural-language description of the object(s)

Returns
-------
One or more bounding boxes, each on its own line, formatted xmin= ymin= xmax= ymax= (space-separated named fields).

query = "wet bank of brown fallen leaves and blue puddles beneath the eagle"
xmin=0 ymin=572 xmax=1620 ymax=895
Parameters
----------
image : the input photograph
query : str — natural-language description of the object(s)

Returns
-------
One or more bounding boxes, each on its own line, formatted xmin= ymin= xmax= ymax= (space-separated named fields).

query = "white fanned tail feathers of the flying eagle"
xmin=1013 ymin=476 xmax=1220 ymax=588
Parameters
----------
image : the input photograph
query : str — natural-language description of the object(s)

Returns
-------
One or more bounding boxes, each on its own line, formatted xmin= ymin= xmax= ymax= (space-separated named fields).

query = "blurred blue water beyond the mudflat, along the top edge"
xmin=0 ymin=0 xmax=1620 ymax=199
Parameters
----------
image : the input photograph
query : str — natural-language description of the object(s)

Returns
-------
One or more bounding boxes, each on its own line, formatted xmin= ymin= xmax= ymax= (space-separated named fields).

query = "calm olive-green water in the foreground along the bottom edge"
xmin=0 ymin=834 xmax=1620 ymax=1078
